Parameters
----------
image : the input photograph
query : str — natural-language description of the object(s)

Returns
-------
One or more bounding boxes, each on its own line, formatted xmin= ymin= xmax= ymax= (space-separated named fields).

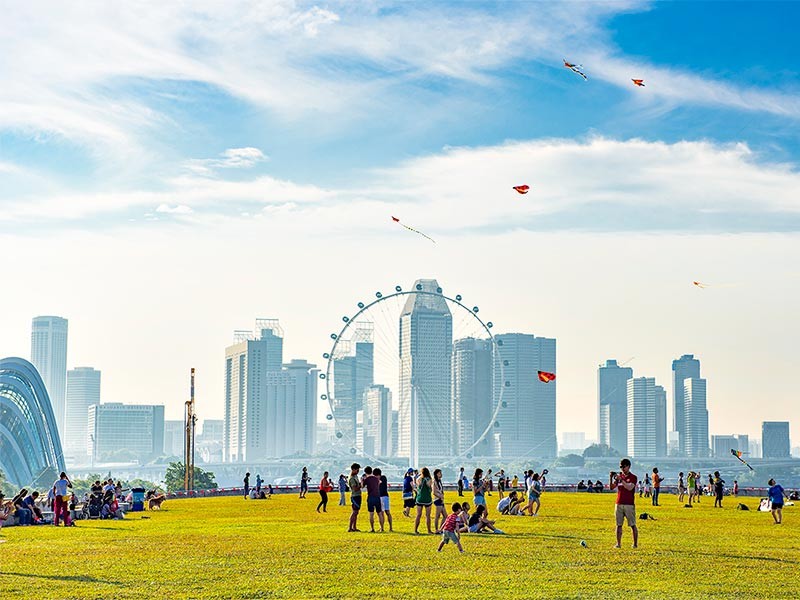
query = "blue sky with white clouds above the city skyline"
xmin=0 ymin=0 xmax=800 ymax=445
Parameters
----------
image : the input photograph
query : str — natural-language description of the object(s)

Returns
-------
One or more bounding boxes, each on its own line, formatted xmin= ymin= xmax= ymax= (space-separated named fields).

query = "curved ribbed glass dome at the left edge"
xmin=0 ymin=358 xmax=65 ymax=486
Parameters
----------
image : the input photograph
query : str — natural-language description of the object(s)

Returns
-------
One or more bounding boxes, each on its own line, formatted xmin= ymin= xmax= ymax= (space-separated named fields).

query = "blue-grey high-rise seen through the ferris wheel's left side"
xmin=333 ymin=323 xmax=375 ymax=439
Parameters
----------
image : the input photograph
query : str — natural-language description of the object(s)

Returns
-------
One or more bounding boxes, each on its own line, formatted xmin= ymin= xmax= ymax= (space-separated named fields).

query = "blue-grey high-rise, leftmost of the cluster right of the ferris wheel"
xmin=597 ymin=360 xmax=633 ymax=454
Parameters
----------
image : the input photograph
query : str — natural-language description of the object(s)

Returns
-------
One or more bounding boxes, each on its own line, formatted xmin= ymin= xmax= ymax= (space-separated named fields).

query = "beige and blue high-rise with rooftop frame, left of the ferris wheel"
xmin=223 ymin=319 xmax=283 ymax=462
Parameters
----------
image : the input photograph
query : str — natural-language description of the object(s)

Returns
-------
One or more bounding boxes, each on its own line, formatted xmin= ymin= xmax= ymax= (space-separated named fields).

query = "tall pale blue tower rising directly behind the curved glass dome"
xmin=31 ymin=317 xmax=68 ymax=438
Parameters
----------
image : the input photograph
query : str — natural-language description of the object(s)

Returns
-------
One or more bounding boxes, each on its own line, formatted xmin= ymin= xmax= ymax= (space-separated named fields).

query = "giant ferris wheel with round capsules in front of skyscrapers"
xmin=319 ymin=279 xmax=510 ymax=476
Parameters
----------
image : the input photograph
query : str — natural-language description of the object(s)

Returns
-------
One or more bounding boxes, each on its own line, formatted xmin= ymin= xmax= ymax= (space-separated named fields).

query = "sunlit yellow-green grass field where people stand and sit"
xmin=0 ymin=492 xmax=800 ymax=600
